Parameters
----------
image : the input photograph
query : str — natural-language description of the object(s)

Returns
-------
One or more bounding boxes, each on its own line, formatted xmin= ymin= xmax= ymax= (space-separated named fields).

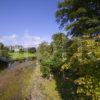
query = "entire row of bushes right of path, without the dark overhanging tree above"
xmin=38 ymin=33 xmax=100 ymax=100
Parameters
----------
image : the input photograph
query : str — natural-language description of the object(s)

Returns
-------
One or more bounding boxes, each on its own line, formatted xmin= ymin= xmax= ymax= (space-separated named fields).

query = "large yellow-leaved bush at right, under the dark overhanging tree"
xmin=62 ymin=38 xmax=100 ymax=99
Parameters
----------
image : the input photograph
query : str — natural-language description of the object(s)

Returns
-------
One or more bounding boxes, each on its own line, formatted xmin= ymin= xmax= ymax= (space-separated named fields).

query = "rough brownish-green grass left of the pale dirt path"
xmin=0 ymin=62 xmax=34 ymax=100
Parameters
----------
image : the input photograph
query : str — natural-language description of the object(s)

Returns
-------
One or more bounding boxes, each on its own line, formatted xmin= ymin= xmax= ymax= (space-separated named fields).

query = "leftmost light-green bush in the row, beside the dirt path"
xmin=37 ymin=42 xmax=52 ymax=78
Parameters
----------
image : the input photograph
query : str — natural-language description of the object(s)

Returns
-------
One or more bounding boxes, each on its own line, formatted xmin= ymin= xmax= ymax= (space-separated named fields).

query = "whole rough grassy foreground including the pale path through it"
xmin=0 ymin=61 xmax=61 ymax=100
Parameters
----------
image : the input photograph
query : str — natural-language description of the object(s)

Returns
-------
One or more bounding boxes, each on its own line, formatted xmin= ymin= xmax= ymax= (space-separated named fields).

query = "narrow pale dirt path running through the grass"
xmin=26 ymin=65 xmax=45 ymax=100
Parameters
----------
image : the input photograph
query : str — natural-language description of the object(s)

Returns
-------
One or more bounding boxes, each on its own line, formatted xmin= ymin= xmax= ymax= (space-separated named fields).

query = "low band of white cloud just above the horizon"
xmin=0 ymin=34 xmax=44 ymax=47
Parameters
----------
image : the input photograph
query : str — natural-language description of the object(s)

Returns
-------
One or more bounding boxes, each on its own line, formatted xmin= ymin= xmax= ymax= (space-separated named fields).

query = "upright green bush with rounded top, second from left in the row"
xmin=51 ymin=33 xmax=67 ymax=71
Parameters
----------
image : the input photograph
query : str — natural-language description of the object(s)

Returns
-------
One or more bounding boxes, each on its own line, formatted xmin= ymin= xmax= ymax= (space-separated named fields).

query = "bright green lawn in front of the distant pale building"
xmin=9 ymin=52 xmax=35 ymax=60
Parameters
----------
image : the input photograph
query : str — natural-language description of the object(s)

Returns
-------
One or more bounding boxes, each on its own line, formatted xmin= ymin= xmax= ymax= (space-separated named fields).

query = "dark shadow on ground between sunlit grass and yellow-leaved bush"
xmin=54 ymin=73 xmax=76 ymax=100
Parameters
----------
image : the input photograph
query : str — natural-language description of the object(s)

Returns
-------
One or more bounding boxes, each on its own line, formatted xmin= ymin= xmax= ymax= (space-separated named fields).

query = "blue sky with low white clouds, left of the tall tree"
xmin=0 ymin=0 xmax=59 ymax=46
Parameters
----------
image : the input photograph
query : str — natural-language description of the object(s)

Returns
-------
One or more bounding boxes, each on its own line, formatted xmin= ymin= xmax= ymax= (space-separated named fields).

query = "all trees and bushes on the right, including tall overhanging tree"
xmin=38 ymin=0 xmax=100 ymax=100
